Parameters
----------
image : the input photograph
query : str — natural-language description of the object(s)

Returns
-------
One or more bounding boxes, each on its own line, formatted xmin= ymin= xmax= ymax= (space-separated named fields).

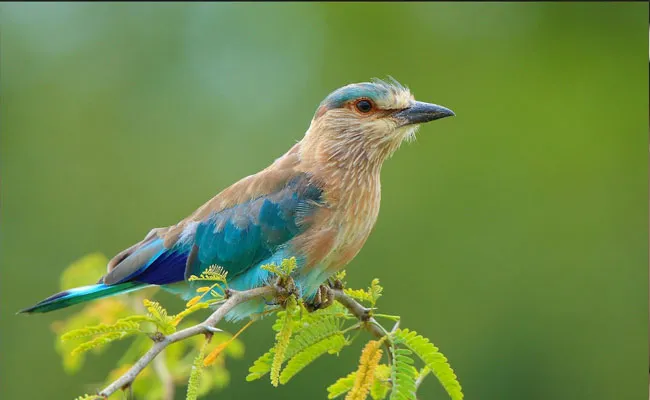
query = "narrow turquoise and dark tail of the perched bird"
xmin=19 ymin=282 xmax=148 ymax=314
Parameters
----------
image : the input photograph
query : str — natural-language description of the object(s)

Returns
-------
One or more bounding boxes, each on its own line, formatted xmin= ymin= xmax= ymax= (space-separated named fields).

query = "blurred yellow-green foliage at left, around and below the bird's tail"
xmin=52 ymin=254 xmax=244 ymax=400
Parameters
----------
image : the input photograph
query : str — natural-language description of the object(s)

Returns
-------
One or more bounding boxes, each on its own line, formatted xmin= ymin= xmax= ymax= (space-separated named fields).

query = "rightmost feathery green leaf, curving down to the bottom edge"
xmin=393 ymin=329 xmax=463 ymax=400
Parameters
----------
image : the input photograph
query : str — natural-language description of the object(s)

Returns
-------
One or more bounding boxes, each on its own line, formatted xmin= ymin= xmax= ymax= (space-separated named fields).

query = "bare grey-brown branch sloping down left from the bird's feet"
xmin=99 ymin=286 xmax=277 ymax=398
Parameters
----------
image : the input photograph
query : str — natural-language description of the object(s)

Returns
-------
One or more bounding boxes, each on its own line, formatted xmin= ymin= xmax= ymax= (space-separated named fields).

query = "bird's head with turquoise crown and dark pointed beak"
xmin=303 ymin=78 xmax=454 ymax=166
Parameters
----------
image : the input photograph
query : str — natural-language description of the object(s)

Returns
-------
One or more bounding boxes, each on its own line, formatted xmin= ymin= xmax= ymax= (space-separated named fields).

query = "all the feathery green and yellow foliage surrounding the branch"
xmin=52 ymin=254 xmax=463 ymax=400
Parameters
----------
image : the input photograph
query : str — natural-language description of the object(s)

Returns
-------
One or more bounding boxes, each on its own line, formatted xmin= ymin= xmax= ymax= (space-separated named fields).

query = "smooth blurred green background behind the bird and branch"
xmin=0 ymin=3 xmax=648 ymax=400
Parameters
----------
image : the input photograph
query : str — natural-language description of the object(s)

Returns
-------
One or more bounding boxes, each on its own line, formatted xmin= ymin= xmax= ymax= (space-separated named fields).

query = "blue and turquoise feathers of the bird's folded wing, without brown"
xmin=124 ymin=174 xmax=322 ymax=287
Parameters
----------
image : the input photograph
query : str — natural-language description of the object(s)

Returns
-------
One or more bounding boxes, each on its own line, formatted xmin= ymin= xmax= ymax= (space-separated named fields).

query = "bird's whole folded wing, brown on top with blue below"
xmin=102 ymin=145 xmax=323 ymax=284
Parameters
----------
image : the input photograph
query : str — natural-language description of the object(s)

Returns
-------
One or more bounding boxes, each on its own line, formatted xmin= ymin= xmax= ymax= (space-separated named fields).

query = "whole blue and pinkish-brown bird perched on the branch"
xmin=20 ymin=77 xmax=455 ymax=320
